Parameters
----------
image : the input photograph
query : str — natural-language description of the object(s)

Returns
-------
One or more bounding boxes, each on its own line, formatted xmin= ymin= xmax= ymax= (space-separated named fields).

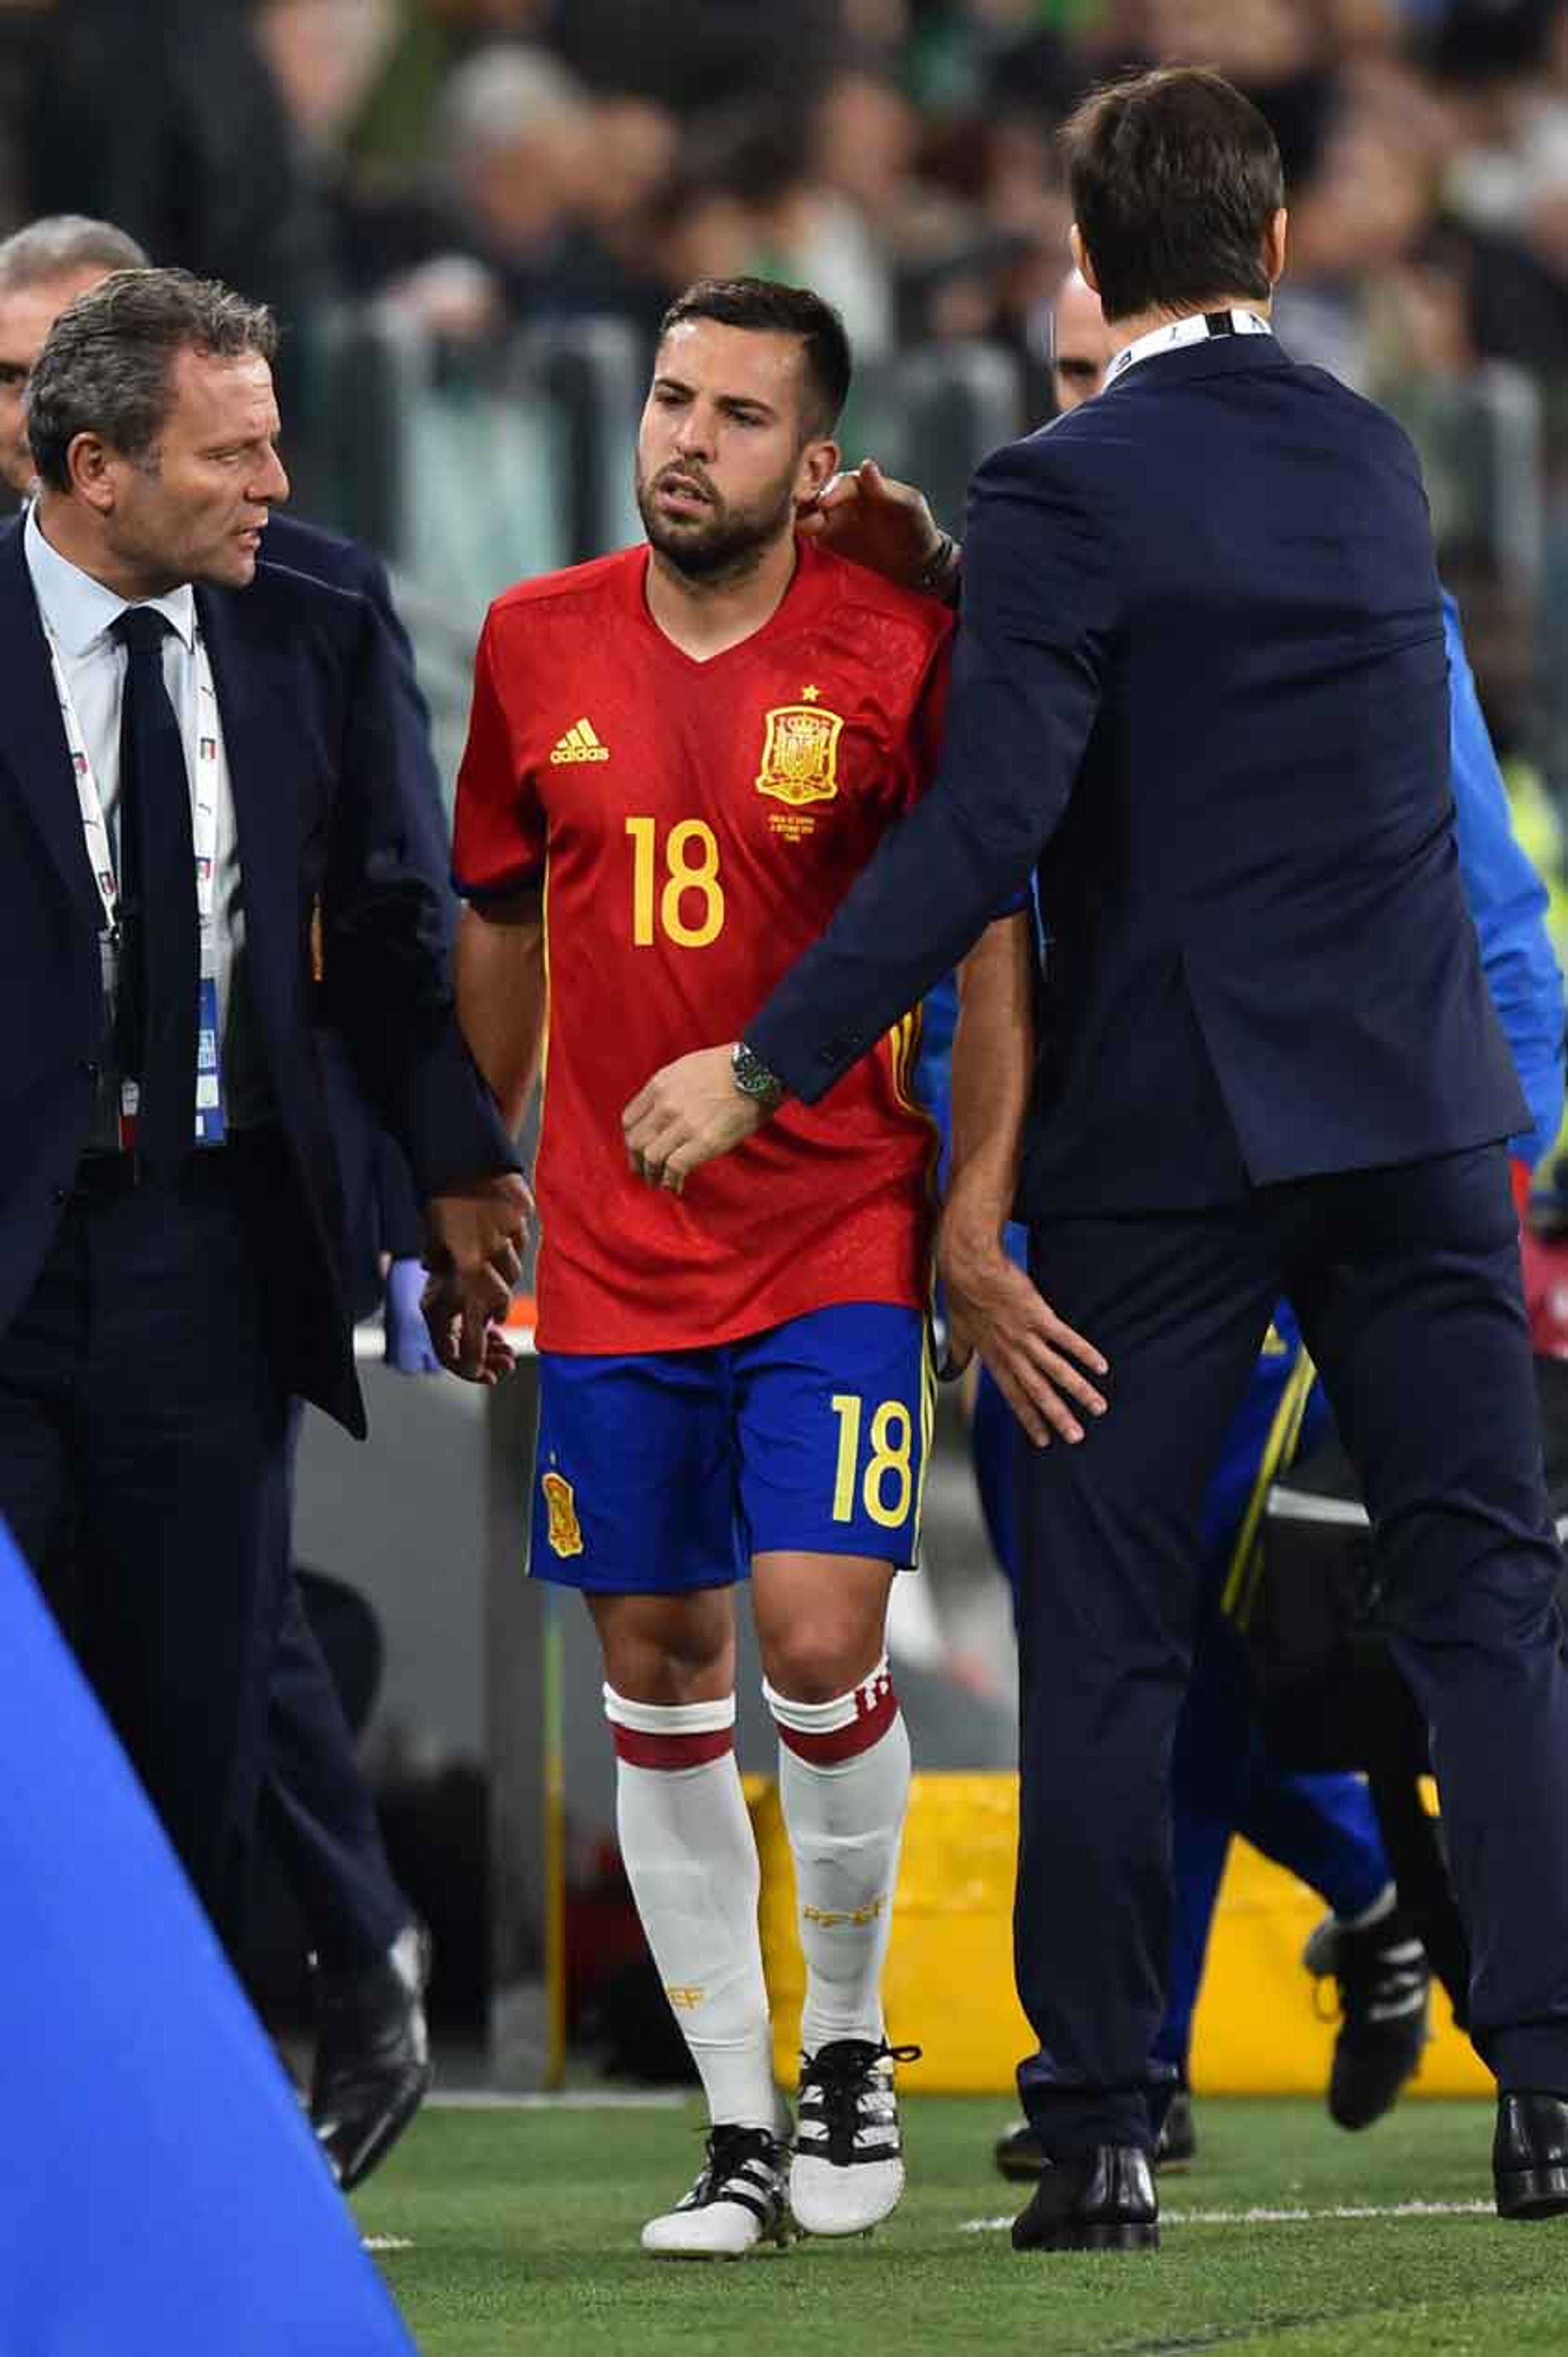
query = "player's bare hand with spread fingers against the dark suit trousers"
xmin=936 ymin=1219 xmax=1106 ymax=1449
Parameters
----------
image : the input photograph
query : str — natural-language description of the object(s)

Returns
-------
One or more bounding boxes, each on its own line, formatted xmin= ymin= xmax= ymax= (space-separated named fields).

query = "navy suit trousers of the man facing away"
xmin=1014 ymin=1146 xmax=1568 ymax=2154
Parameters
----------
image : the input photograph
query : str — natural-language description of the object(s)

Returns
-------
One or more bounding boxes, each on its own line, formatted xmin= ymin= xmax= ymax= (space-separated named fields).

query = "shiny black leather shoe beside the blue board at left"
xmin=311 ymin=1923 xmax=432 ymax=2192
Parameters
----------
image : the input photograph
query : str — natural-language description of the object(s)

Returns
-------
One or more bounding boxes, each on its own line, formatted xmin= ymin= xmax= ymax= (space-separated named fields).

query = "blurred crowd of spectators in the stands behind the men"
xmin=0 ymin=0 xmax=1568 ymax=966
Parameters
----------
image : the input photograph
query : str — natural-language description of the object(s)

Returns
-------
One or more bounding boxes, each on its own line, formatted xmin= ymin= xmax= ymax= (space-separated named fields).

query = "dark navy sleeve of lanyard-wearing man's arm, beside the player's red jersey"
xmin=321 ymin=599 xmax=517 ymax=1197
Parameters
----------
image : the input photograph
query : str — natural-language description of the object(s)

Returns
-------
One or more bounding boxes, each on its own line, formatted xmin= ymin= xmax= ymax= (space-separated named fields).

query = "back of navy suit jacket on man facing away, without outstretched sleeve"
xmin=1016 ymin=339 xmax=1519 ymax=1204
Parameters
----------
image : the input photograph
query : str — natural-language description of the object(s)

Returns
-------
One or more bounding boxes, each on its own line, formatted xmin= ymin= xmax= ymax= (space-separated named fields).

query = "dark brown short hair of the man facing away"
xmin=1061 ymin=66 xmax=1285 ymax=318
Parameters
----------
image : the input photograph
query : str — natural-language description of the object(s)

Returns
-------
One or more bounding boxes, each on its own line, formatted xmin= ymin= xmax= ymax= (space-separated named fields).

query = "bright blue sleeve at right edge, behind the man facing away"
xmin=1443 ymin=596 xmax=1563 ymax=1167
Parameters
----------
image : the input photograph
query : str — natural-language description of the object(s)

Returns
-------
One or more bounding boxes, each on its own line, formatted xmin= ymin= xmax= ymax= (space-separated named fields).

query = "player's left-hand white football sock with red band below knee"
xmin=604 ymin=1685 xmax=780 ymax=2131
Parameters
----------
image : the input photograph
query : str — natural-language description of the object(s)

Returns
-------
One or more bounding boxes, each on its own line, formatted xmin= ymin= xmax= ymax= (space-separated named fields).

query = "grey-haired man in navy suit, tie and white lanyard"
xmin=0 ymin=271 xmax=523 ymax=1970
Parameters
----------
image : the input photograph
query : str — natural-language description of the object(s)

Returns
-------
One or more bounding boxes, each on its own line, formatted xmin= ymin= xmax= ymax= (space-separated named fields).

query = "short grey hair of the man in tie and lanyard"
xmin=24 ymin=271 xmax=278 ymax=490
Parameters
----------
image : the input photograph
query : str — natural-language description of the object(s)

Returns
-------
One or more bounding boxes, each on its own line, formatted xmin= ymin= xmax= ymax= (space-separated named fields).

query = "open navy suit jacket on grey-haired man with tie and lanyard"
xmin=0 ymin=523 xmax=514 ymax=1431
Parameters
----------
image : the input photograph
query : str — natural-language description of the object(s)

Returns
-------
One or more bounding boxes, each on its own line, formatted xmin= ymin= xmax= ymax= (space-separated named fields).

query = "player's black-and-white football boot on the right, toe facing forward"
xmin=790 ymin=2039 xmax=920 ymax=2234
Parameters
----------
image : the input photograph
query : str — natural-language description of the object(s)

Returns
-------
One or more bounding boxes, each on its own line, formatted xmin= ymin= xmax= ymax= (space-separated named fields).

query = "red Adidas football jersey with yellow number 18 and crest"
xmin=455 ymin=542 xmax=950 ymax=1353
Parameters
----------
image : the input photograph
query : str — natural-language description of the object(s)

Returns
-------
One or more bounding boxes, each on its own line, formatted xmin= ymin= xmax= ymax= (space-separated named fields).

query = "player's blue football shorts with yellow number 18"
xmin=528 ymin=1301 xmax=934 ymax=1596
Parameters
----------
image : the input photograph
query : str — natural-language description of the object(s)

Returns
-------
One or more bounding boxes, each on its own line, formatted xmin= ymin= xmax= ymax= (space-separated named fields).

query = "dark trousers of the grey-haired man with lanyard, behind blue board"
xmin=0 ymin=1148 xmax=285 ymax=1944
